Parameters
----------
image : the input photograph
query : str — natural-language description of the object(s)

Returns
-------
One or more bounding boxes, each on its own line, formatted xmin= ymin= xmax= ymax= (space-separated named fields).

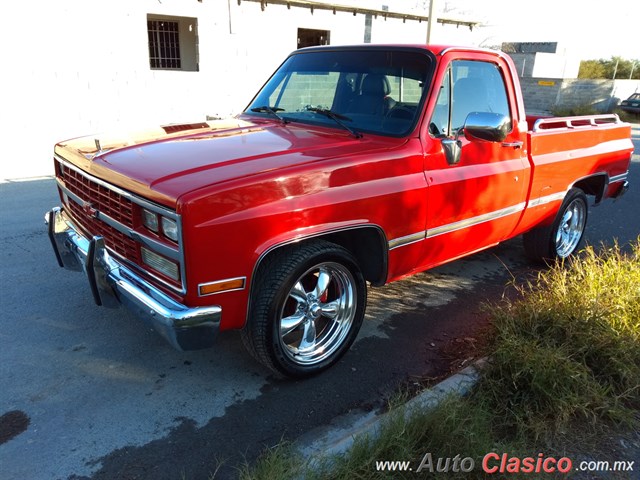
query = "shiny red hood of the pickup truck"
xmin=55 ymin=118 xmax=405 ymax=208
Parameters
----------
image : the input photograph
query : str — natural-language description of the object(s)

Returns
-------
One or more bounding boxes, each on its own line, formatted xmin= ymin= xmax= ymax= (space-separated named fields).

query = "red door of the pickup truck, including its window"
xmin=424 ymin=54 xmax=530 ymax=266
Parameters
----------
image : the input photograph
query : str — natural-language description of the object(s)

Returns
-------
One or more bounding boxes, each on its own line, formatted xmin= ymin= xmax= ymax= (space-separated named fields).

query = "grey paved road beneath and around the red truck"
xmin=0 ymin=127 xmax=640 ymax=480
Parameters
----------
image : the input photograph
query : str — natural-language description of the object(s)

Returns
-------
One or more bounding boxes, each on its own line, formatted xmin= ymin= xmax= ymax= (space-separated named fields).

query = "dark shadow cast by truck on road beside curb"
xmin=71 ymin=247 xmax=524 ymax=480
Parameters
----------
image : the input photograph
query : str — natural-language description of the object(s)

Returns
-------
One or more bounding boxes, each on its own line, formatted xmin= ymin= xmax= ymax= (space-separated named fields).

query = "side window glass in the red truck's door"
xmin=429 ymin=60 xmax=510 ymax=136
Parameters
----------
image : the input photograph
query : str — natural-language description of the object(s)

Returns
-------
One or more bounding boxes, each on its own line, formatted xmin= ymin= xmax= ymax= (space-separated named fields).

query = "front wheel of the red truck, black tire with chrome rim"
xmin=242 ymin=241 xmax=367 ymax=378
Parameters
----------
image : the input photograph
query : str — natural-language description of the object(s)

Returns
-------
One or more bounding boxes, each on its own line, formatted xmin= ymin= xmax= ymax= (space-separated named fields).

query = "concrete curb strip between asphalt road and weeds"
xmin=294 ymin=359 xmax=486 ymax=465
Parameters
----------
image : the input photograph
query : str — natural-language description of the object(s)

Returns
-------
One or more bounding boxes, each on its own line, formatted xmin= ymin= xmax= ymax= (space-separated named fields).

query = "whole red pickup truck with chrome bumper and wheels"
xmin=47 ymin=45 xmax=633 ymax=377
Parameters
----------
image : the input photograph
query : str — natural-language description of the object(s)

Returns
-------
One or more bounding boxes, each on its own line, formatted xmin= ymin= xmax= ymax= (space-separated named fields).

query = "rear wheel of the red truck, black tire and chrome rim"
xmin=522 ymin=188 xmax=589 ymax=262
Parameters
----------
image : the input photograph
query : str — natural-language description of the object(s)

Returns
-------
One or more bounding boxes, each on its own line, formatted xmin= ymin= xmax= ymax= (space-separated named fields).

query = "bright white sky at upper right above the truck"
xmin=380 ymin=0 xmax=640 ymax=60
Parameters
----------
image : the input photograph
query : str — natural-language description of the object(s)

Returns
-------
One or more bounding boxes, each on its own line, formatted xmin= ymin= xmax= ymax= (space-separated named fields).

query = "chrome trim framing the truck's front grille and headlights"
xmin=54 ymin=155 xmax=187 ymax=294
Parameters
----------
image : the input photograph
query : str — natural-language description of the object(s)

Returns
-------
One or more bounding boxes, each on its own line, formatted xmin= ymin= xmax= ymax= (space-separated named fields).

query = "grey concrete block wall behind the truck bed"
xmin=520 ymin=78 xmax=640 ymax=112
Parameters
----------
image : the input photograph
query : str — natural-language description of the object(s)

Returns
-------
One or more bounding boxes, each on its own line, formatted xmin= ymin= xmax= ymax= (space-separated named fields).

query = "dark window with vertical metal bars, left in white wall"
xmin=147 ymin=20 xmax=182 ymax=70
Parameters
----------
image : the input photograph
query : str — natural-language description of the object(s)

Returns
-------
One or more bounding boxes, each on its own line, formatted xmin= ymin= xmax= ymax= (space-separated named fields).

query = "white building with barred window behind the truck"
xmin=0 ymin=0 xmax=475 ymax=179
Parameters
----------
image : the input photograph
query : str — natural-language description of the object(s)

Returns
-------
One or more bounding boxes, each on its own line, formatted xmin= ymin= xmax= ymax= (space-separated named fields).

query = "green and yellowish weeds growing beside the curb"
xmin=241 ymin=237 xmax=640 ymax=480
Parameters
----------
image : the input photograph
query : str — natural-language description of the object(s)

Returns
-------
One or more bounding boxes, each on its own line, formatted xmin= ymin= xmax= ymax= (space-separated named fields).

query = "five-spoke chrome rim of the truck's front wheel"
xmin=278 ymin=262 xmax=357 ymax=365
